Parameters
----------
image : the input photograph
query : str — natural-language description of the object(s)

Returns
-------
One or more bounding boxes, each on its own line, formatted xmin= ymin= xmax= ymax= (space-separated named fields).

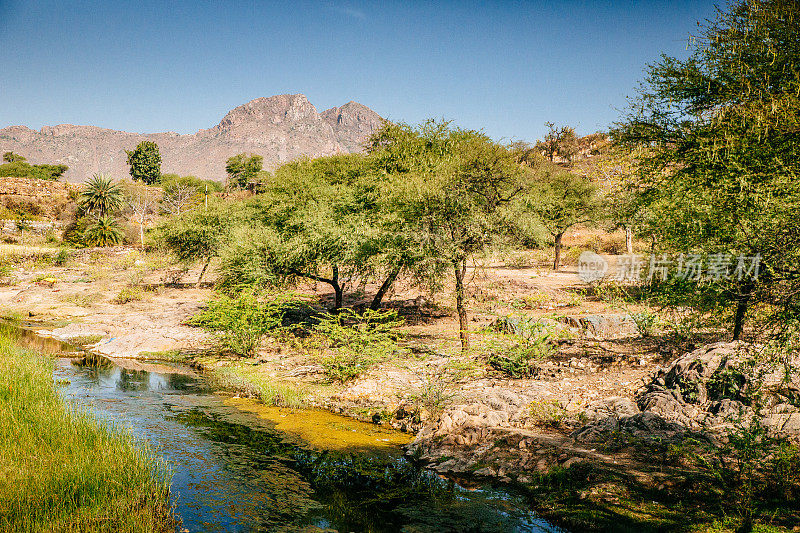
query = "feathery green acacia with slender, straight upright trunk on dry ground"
xmin=371 ymin=120 xmax=527 ymax=351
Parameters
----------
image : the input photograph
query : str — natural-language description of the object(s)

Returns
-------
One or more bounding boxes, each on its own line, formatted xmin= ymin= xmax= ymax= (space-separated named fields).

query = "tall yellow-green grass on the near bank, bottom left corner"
xmin=0 ymin=336 xmax=174 ymax=533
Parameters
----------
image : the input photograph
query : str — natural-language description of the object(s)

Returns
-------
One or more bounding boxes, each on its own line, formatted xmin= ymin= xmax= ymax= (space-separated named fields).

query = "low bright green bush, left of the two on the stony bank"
xmin=188 ymin=290 xmax=306 ymax=356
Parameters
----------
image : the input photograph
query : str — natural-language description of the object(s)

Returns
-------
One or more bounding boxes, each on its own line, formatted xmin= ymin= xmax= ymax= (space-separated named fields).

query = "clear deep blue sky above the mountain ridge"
xmin=0 ymin=0 xmax=724 ymax=141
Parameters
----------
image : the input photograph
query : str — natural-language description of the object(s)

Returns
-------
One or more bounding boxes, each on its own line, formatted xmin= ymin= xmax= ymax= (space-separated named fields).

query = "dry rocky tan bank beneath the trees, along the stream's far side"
xmin=0 ymin=249 xmax=800 ymax=532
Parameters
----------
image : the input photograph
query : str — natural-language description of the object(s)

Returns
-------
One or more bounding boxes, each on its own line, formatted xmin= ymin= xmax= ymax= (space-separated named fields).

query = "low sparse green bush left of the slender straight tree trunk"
xmin=308 ymin=309 xmax=403 ymax=382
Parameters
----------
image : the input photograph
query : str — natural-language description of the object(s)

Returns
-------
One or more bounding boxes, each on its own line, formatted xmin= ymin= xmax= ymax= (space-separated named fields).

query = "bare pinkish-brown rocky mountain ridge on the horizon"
xmin=0 ymin=94 xmax=382 ymax=182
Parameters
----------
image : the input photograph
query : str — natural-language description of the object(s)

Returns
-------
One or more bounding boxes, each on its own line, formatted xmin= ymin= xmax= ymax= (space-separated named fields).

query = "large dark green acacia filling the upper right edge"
xmin=612 ymin=0 xmax=800 ymax=339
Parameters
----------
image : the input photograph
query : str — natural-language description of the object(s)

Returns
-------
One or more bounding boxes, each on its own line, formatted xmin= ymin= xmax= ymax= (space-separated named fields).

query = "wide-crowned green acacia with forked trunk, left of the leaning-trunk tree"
xmin=223 ymin=154 xmax=374 ymax=309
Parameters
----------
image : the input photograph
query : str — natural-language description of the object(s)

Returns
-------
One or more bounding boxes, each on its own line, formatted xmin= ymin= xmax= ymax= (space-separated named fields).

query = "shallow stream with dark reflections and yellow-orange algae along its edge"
xmin=9 ymin=322 xmax=563 ymax=533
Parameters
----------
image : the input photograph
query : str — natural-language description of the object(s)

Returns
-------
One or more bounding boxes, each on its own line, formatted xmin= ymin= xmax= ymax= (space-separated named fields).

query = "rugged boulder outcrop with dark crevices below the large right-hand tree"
xmin=573 ymin=342 xmax=800 ymax=443
